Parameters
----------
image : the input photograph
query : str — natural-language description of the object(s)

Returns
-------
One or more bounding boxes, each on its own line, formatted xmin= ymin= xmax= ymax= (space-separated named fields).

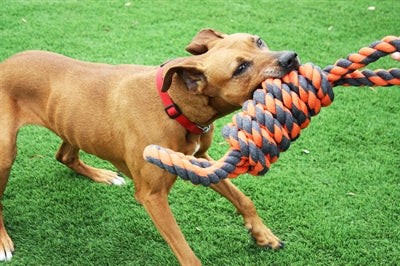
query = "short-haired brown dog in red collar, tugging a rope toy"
xmin=0 ymin=29 xmax=299 ymax=265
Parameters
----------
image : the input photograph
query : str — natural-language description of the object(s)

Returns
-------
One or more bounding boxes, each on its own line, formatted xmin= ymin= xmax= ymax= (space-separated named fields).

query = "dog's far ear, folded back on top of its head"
xmin=186 ymin=29 xmax=227 ymax=55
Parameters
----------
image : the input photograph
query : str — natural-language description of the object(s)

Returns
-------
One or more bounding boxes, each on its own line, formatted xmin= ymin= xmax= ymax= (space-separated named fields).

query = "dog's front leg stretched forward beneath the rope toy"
xmin=211 ymin=179 xmax=283 ymax=249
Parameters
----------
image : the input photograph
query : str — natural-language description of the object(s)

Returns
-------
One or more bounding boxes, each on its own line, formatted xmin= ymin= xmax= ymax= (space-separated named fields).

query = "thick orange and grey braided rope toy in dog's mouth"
xmin=143 ymin=36 xmax=400 ymax=186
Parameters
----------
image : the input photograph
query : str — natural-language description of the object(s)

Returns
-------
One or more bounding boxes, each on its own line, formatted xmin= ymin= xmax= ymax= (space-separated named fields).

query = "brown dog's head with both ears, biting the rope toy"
xmin=162 ymin=29 xmax=299 ymax=109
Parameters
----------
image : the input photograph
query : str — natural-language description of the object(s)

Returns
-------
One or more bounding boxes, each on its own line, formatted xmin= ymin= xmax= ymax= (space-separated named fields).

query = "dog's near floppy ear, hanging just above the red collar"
xmin=161 ymin=58 xmax=207 ymax=94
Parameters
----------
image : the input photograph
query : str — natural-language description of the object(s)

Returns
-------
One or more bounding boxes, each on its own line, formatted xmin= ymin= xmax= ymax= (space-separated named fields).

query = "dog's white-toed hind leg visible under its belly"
xmin=56 ymin=141 xmax=125 ymax=185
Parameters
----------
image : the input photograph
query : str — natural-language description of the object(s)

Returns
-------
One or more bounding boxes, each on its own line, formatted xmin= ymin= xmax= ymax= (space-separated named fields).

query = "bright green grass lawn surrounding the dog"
xmin=0 ymin=0 xmax=400 ymax=265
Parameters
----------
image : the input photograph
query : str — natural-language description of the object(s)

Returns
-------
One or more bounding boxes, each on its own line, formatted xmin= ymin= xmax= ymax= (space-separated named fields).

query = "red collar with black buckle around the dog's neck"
xmin=156 ymin=66 xmax=210 ymax=134
